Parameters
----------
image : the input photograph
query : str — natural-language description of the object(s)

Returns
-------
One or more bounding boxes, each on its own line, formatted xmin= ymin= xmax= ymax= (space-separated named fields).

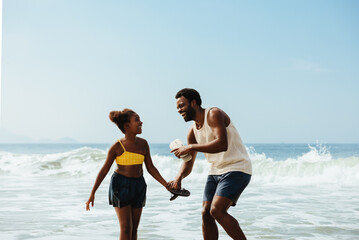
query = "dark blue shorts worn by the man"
xmin=203 ymin=171 xmax=251 ymax=206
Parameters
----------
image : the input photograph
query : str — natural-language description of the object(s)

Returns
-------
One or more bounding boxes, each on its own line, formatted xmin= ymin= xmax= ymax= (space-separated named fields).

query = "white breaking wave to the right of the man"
xmin=249 ymin=146 xmax=359 ymax=185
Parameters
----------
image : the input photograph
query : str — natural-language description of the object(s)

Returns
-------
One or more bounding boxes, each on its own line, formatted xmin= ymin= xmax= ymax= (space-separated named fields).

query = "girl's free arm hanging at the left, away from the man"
xmin=86 ymin=145 xmax=116 ymax=211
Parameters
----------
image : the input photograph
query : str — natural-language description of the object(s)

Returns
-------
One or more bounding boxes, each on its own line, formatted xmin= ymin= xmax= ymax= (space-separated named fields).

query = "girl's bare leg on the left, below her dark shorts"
xmin=115 ymin=205 xmax=133 ymax=240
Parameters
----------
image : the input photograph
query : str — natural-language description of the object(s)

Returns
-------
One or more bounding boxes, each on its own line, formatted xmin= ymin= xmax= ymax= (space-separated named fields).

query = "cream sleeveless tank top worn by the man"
xmin=192 ymin=108 xmax=252 ymax=175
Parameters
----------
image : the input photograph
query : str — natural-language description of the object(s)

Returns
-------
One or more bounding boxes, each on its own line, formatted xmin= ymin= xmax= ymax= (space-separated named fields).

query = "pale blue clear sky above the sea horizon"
xmin=1 ymin=0 xmax=359 ymax=143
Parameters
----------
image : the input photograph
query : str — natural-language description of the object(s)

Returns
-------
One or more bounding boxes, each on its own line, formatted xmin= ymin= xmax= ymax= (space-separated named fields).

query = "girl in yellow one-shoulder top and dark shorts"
xmin=86 ymin=109 xmax=167 ymax=240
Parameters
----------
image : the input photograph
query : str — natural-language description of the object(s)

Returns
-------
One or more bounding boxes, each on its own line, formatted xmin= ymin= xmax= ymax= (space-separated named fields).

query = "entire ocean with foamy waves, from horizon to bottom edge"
xmin=0 ymin=143 xmax=359 ymax=240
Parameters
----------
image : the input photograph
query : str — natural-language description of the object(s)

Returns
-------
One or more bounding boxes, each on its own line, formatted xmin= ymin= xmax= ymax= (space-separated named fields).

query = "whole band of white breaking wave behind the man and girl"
xmin=0 ymin=146 xmax=359 ymax=185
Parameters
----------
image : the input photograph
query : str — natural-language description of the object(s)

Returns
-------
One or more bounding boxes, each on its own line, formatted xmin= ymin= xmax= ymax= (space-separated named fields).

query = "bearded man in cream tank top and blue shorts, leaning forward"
xmin=169 ymin=88 xmax=252 ymax=240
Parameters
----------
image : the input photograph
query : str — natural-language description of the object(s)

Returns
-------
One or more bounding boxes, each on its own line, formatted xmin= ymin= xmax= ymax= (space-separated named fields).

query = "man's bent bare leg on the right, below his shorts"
xmin=210 ymin=196 xmax=247 ymax=240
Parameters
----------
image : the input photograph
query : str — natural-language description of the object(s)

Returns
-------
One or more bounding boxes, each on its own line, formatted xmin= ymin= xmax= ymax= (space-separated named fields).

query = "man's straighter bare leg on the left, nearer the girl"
xmin=202 ymin=201 xmax=218 ymax=240
